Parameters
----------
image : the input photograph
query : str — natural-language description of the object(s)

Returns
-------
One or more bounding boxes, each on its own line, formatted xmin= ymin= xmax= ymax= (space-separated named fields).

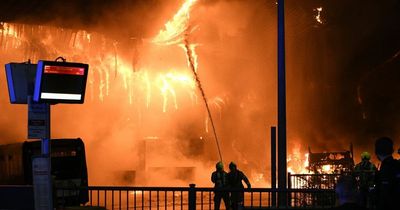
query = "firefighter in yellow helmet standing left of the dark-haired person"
xmin=354 ymin=152 xmax=377 ymax=207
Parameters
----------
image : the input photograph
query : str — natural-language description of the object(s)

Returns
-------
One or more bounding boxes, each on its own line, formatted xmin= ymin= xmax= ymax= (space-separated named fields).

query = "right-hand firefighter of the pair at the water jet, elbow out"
xmin=228 ymin=162 xmax=251 ymax=210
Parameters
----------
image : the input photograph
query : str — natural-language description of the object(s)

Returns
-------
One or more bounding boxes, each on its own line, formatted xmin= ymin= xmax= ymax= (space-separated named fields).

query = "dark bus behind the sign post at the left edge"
xmin=0 ymin=138 xmax=89 ymax=206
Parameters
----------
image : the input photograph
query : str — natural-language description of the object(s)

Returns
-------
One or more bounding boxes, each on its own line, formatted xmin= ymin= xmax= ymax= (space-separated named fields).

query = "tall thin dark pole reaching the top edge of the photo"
xmin=278 ymin=0 xmax=287 ymax=206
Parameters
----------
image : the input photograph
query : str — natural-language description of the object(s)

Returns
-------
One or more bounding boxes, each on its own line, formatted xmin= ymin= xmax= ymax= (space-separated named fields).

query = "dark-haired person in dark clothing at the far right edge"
xmin=375 ymin=137 xmax=400 ymax=210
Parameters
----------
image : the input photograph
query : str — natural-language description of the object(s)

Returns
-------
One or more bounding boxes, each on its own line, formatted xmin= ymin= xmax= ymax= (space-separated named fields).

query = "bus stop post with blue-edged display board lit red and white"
xmin=6 ymin=57 xmax=89 ymax=210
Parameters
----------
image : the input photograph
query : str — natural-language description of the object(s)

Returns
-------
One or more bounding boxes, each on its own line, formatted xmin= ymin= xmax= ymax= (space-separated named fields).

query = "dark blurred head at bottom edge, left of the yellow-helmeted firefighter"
xmin=333 ymin=175 xmax=366 ymax=210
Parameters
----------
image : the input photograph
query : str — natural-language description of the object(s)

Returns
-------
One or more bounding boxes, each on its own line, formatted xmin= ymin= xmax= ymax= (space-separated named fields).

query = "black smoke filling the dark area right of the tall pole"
xmin=286 ymin=0 xmax=400 ymax=153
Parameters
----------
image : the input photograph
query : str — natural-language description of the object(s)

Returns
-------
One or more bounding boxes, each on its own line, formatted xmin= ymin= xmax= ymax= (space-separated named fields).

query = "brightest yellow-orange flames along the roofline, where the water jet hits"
xmin=0 ymin=0 xmax=219 ymax=123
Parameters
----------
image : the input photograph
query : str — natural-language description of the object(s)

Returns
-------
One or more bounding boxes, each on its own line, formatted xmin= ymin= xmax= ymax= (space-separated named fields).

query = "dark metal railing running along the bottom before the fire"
xmin=56 ymin=185 xmax=335 ymax=210
